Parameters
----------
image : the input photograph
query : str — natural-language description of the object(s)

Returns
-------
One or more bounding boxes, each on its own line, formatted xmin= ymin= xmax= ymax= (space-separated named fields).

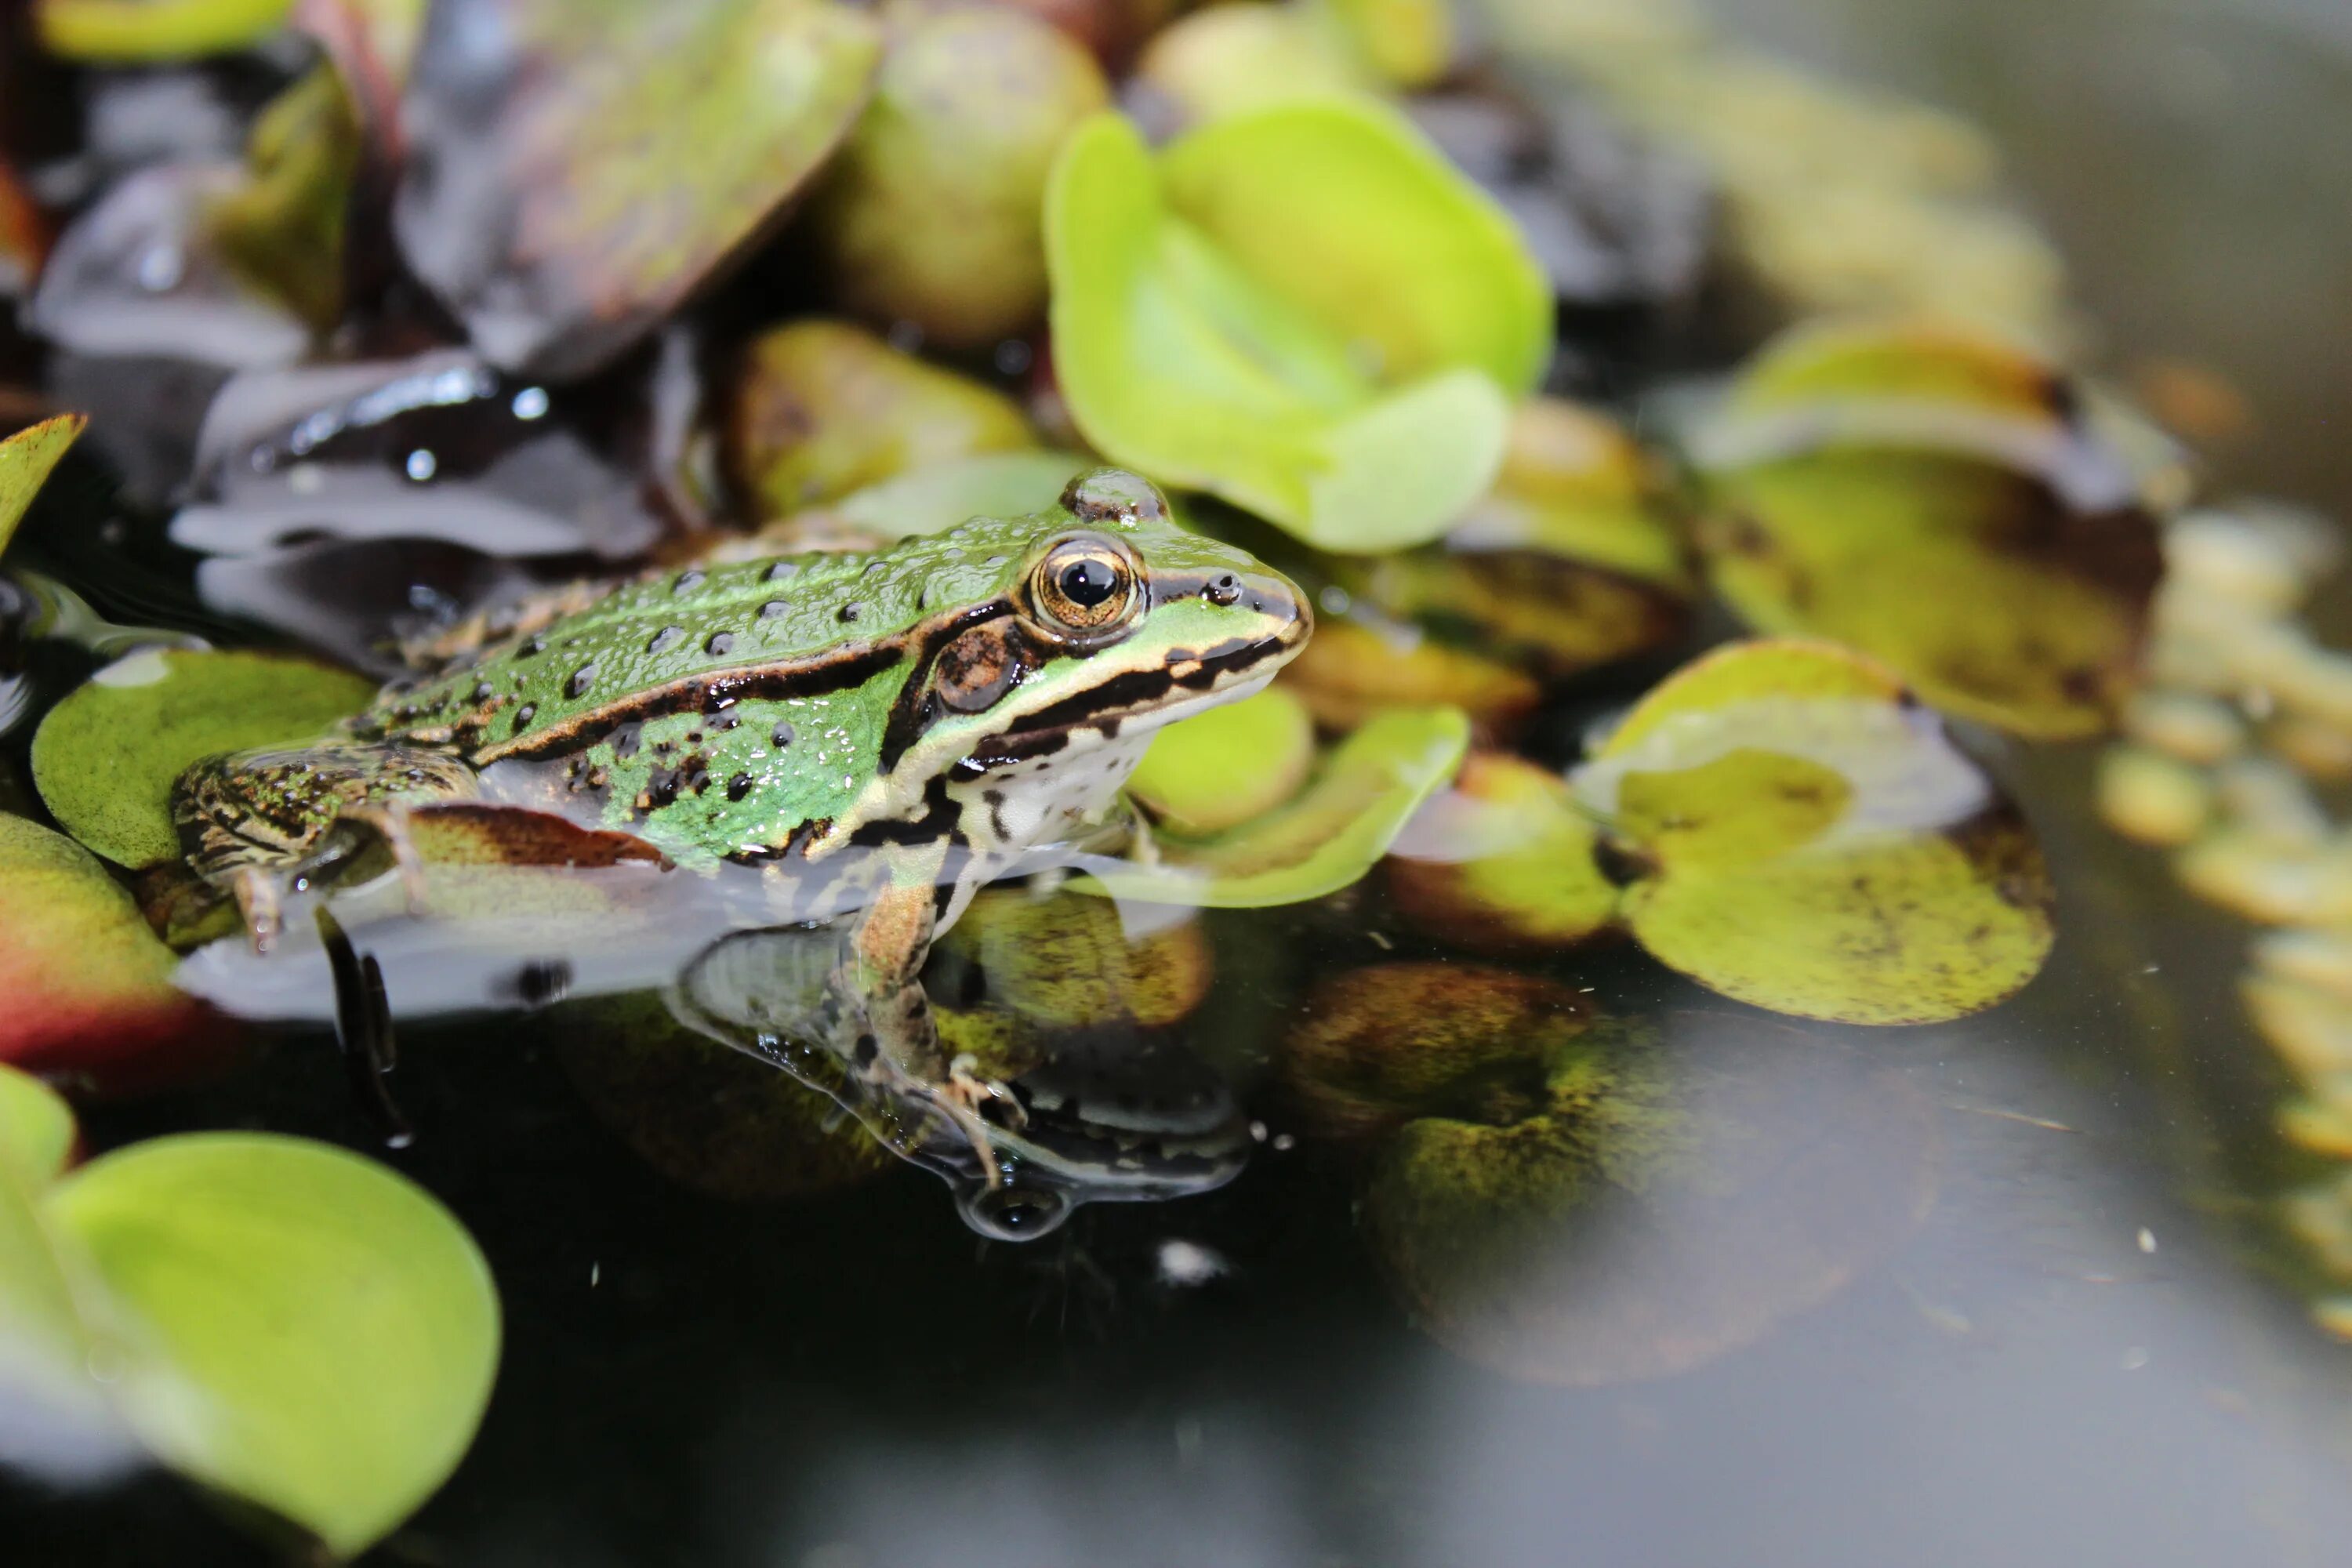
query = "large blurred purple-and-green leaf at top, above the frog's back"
xmin=393 ymin=0 xmax=882 ymax=381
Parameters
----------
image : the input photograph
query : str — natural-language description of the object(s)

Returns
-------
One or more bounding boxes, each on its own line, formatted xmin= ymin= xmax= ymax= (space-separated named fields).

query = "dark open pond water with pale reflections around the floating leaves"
xmin=13 ymin=0 xmax=2352 ymax=1568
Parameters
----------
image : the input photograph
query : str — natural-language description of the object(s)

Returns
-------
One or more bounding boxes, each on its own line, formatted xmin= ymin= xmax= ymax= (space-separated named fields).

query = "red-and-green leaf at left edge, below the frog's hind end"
xmin=0 ymin=815 xmax=233 ymax=1091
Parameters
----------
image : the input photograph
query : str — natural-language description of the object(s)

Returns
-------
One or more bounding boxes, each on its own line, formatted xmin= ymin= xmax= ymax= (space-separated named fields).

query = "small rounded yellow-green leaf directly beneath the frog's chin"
xmin=1127 ymin=687 xmax=1315 ymax=837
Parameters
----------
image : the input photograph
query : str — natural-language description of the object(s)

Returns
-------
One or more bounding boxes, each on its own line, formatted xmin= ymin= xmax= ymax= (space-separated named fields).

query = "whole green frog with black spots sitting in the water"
xmin=174 ymin=470 xmax=1310 ymax=1241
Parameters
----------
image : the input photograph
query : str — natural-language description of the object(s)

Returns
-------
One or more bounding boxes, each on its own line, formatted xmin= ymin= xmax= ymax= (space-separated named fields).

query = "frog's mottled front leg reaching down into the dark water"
xmin=842 ymin=844 xmax=1021 ymax=1187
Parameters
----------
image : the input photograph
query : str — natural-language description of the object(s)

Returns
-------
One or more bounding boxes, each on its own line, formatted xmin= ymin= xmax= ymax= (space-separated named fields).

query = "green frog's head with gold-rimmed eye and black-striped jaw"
xmin=882 ymin=468 xmax=1312 ymax=818
